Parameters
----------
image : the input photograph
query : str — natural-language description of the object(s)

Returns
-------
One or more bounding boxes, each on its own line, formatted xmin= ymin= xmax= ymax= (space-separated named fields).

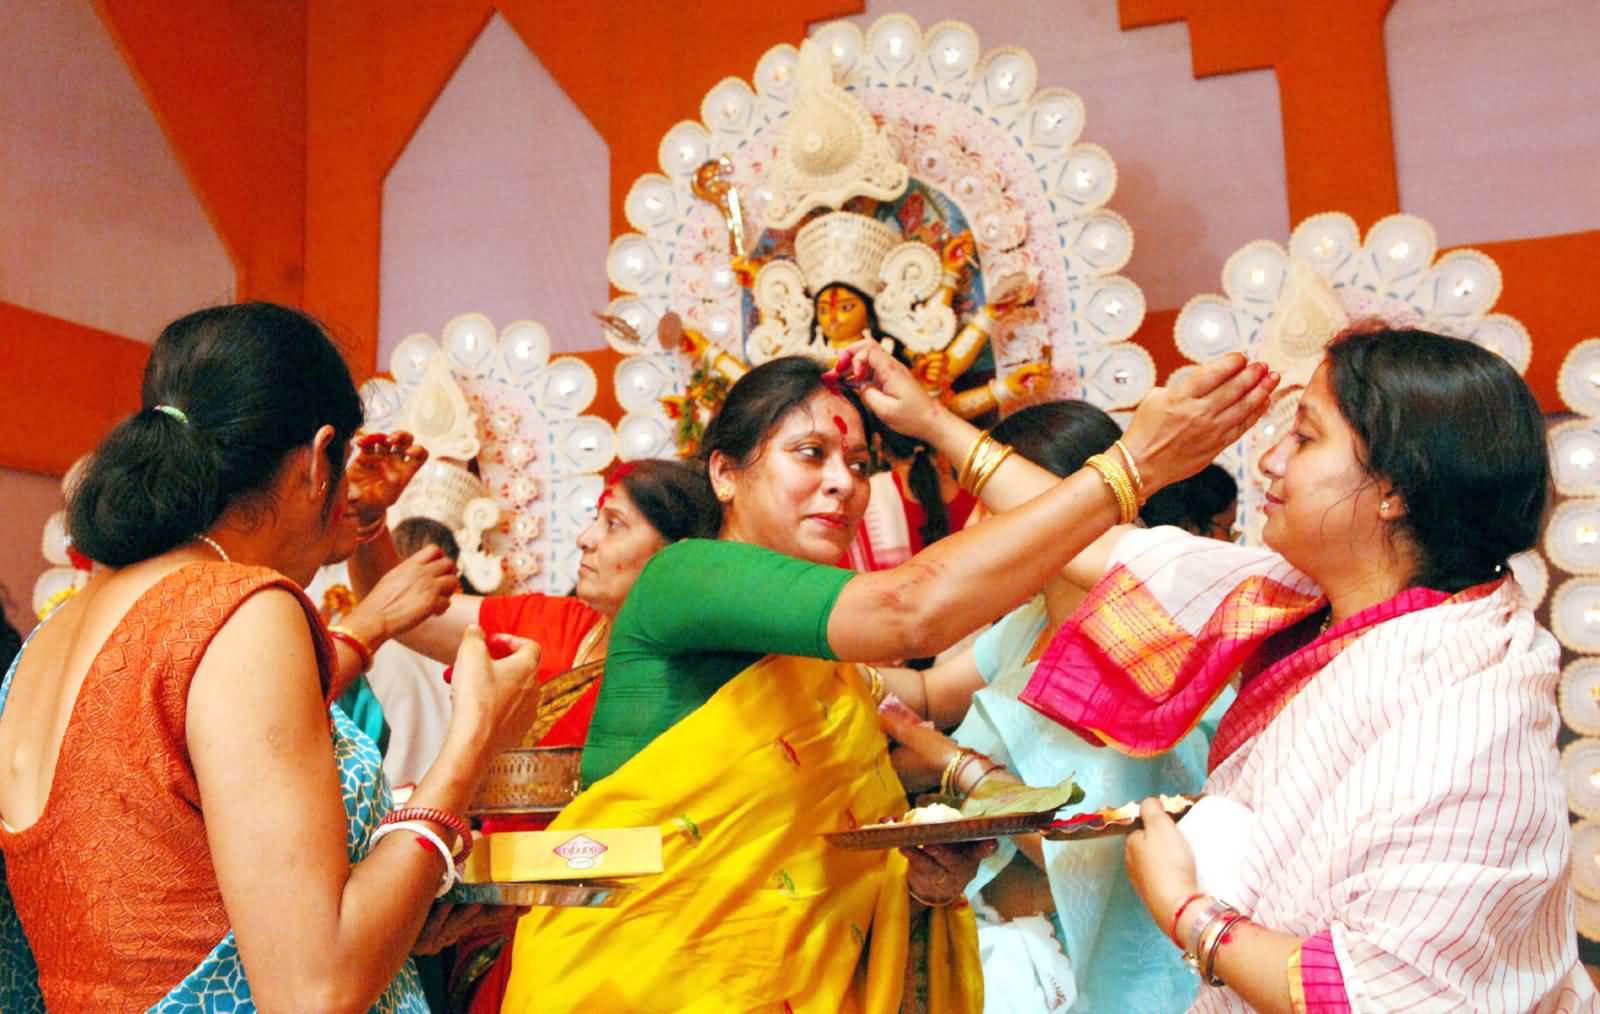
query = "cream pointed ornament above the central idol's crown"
xmin=765 ymin=38 xmax=910 ymax=229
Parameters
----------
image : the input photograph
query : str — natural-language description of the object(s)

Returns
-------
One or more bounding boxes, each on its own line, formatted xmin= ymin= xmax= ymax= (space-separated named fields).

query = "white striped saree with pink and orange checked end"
xmin=1024 ymin=528 xmax=1600 ymax=1011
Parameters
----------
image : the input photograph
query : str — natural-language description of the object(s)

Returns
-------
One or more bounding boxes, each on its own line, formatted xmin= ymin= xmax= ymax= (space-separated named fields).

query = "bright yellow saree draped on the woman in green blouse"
xmin=501 ymin=656 xmax=982 ymax=1014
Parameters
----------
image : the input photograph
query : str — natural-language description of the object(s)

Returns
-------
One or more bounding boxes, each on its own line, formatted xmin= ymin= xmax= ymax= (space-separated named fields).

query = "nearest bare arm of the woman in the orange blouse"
xmin=186 ymin=589 xmax=539 ymax=1011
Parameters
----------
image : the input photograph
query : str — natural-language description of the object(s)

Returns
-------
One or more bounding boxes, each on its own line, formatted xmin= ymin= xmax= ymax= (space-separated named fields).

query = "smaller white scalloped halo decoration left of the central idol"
xmin=362 ymin=313 xmax=614 ymax=595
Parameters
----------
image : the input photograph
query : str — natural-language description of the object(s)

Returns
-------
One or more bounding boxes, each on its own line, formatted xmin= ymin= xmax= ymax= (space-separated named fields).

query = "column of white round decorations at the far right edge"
xmin=1542 ymin=337 xmax=1600 ymax=940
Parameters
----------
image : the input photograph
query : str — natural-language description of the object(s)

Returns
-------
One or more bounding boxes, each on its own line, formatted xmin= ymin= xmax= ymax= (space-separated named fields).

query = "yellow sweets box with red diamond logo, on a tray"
xmin=461 ymin=827 xmax=661 ymax=884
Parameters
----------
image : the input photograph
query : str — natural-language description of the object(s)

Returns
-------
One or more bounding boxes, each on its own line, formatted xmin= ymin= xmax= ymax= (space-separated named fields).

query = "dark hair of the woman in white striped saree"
xmin=1328 ymin=328 xmax=1550 ymax=592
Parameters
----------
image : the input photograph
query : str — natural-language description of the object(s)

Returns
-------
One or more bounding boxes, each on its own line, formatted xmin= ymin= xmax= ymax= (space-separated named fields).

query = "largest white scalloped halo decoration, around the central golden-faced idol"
xmin=606 ymin=14 xmax=1155 ymax=457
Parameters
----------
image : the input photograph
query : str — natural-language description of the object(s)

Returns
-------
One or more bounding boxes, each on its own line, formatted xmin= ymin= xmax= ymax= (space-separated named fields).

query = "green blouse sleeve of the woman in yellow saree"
xmin=616 ymin=539 xmax=854 ymax=659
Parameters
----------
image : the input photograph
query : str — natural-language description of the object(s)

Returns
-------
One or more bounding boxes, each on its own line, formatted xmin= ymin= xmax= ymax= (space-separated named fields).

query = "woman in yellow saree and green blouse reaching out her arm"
xmin=502 ymin=344 xmax=1275 ymax=1014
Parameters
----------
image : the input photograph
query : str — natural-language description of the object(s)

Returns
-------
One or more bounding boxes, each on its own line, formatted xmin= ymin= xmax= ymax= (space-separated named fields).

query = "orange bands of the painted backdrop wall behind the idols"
xmin=0 ymin=0 xmax=1600 ymax=473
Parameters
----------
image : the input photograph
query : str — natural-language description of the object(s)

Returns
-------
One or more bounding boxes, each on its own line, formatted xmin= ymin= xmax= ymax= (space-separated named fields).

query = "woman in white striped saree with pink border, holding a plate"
xmin=1017 ymin=331 xmax=1600 ymax=1011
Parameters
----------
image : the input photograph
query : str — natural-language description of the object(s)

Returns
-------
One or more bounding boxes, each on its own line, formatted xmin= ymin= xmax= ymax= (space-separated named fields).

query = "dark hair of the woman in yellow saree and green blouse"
xmin=700 ymin=355 xmax=877 ymax=470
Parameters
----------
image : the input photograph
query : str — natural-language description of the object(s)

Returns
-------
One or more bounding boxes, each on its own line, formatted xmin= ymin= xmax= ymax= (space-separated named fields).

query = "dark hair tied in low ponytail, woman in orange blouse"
xmin=67 ymin=302 xmax=362 ymax=566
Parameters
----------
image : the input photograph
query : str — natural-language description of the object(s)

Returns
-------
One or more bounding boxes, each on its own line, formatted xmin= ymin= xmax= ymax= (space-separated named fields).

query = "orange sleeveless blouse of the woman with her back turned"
xmin=0 ymin=561 xmax=331 ymax=1012
